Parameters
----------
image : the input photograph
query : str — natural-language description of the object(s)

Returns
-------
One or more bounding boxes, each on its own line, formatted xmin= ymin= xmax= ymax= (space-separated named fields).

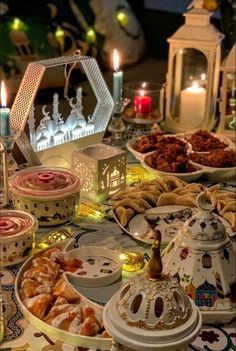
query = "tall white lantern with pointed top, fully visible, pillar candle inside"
xmin=165 ymin=0 xmax=224 ymax=132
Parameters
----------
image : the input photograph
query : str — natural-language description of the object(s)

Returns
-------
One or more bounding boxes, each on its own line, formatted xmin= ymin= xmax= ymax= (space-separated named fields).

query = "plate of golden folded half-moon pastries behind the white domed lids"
xmin=110 ymin=176 xmax=236 ymax=246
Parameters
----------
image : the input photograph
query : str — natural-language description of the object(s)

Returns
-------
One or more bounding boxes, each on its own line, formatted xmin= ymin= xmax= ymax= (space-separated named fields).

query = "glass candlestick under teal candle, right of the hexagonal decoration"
xmin=108 ymin=98 xmax=130 ymax=147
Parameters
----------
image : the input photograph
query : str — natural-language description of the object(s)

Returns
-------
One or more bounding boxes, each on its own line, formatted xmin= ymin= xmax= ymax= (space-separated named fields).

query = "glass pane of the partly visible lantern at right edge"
xmin=225 ymin=72 xmax=236 ymax=131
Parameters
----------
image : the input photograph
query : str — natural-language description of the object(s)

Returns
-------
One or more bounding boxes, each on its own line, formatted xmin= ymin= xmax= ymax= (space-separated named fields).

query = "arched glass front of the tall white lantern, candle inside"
xmin=170 ymin=48 xmax=208 ymax=128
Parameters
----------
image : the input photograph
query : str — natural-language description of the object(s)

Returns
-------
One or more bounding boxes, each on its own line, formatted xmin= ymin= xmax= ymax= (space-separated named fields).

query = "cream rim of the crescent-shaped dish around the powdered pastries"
xmin=15 ymin=240 xmax=112 ymax=350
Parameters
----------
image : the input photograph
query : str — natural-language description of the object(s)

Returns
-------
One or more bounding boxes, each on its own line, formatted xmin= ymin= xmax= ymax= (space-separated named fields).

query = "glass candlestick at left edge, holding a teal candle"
xmin=0 ymin=131 xmax=19 ymax=207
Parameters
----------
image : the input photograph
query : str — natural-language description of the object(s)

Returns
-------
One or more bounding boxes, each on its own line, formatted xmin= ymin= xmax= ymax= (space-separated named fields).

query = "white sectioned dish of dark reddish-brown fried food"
xmin=127 ymin=130 xmax=236 ymax=182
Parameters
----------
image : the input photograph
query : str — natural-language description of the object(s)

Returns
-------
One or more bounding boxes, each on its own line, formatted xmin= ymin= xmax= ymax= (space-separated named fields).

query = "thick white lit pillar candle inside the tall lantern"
xmin=180 ymin=82 xmax=206 ymax=128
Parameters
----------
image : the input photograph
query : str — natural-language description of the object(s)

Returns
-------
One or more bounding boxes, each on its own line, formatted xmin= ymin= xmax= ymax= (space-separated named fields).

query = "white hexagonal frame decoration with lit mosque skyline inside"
xmin=11 ymin=54 xmax=114 ymax=167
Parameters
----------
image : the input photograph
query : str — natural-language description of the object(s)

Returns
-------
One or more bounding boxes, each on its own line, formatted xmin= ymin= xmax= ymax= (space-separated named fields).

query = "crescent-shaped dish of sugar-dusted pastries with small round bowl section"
xmin=15 ymin=242 xmax=117 ymax=350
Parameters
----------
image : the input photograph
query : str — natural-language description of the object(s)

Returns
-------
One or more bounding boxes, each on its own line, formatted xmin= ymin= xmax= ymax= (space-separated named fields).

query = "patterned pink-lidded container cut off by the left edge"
xmin=0 ymin=210 xmax=38 ymax=267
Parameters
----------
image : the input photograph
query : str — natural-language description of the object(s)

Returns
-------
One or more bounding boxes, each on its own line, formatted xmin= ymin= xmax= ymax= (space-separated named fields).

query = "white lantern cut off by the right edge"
xmin=219 ymin=45 xmax=236 ymax=138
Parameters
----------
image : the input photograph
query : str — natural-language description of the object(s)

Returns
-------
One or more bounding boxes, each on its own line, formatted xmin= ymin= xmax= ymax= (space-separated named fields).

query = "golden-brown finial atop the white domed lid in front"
xmin=145 ymin=217 xmax=163 ymax=280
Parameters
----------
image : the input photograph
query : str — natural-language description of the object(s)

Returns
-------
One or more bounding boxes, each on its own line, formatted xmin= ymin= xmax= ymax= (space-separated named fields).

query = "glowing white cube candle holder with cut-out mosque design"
xmin=71 ymin=144 xmax=126 ymax=201
